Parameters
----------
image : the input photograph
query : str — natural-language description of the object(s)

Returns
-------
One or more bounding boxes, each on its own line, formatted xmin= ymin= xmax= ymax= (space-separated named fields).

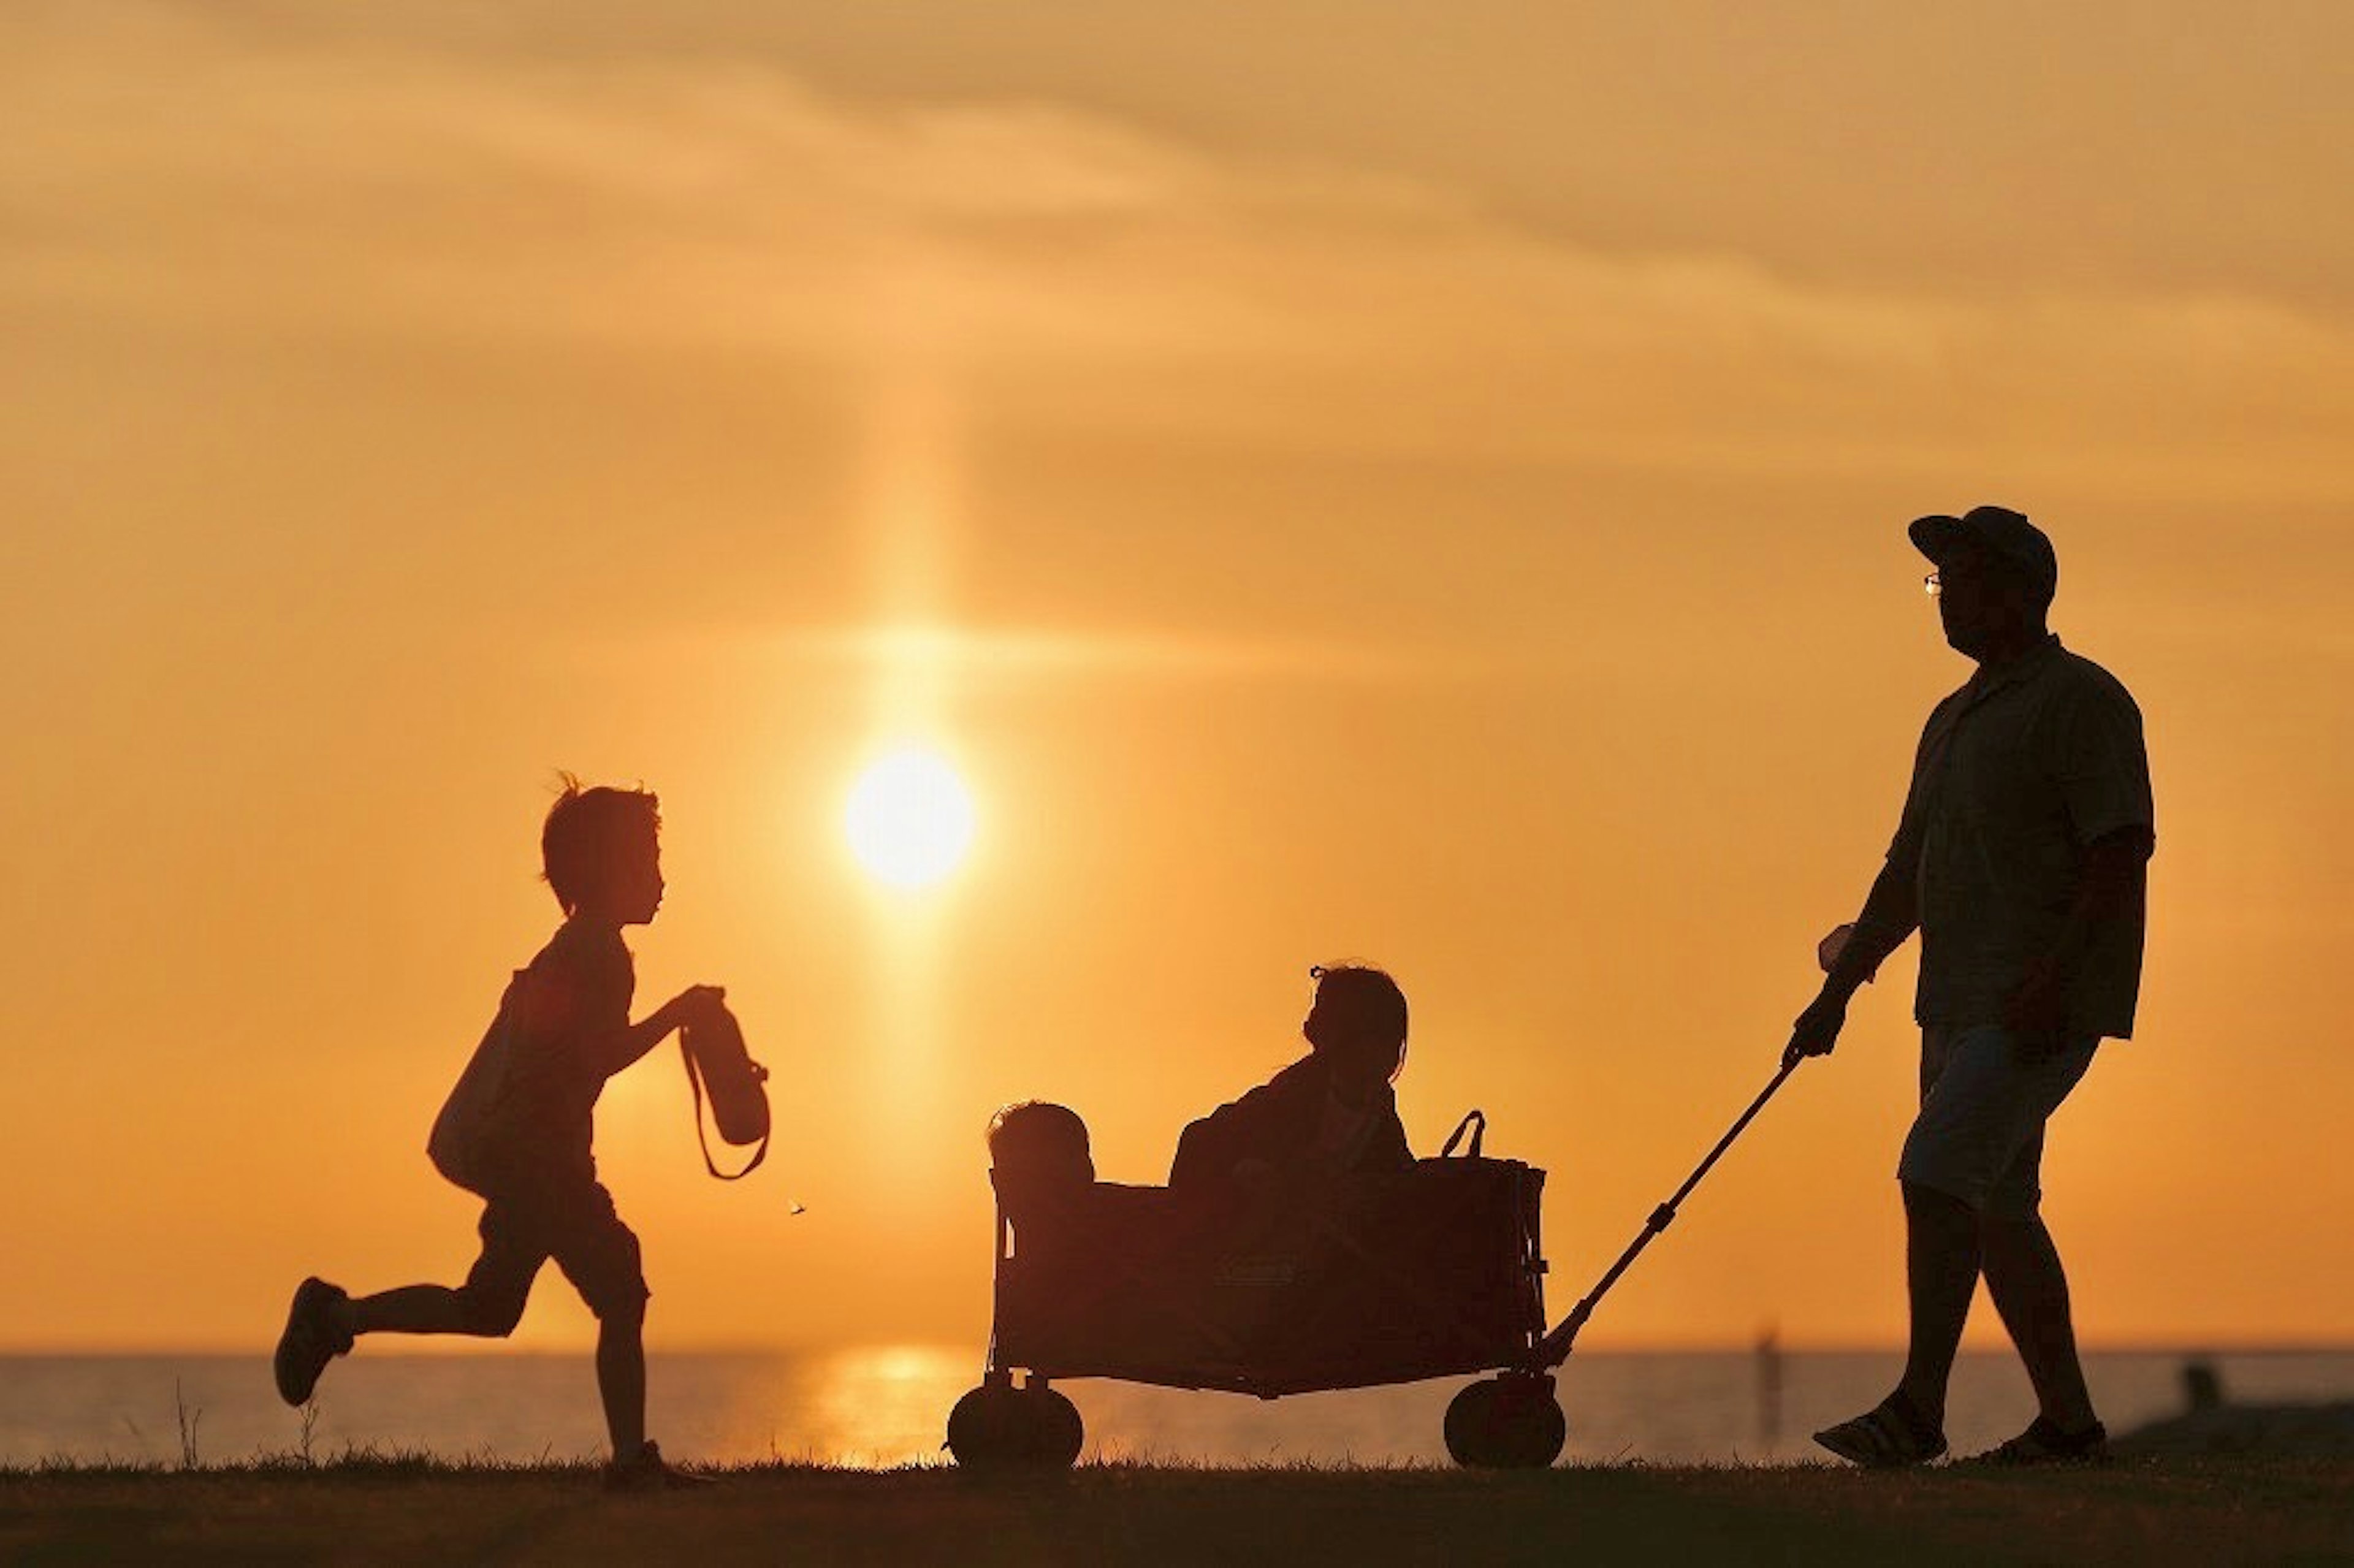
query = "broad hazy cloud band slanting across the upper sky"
xmin=13 ymin=7 xmax=2354 ymax=504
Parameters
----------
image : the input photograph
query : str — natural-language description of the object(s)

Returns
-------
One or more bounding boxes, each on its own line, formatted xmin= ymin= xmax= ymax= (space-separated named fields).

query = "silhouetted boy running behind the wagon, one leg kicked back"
xmin=275 ymin=777 xmax=723 ymax=1486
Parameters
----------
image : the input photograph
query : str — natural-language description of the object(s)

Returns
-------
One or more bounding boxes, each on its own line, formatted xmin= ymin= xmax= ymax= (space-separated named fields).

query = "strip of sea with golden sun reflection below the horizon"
xmin=0 ymin=1347 xmax=2354 ymax=1467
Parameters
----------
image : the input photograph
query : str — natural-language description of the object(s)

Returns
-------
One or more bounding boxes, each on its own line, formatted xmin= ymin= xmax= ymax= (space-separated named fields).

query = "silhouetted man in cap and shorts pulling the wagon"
xmin=1785 ymin=506 xmax=2156 ymax=1467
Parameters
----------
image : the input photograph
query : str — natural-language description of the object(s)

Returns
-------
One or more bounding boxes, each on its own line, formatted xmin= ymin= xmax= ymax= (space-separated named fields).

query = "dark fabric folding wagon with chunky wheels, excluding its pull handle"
xmin=949 ymin=1111 xmax=1566 ymax=1469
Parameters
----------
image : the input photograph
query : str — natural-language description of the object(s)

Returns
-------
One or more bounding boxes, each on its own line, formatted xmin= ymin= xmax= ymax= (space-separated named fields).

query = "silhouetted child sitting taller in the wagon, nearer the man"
xmin=1170 ymin=965 xmax=1415 ymax=1191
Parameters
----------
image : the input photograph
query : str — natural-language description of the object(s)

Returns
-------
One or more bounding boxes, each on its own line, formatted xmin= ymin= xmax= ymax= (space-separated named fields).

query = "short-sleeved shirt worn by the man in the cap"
xmin=1888 ymin=638 xmax=2156 ymax=1038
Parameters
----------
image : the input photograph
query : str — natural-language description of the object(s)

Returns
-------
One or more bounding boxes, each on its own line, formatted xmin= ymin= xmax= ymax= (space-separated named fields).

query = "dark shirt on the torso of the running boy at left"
xmin=490 ymin=921 xmax=638 ymax=1184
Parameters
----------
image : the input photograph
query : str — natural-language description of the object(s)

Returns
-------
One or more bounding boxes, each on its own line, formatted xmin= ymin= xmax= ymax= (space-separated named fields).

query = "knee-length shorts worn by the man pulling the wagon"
xmin=1897 ymin=1024 xmax=2100 ymax=1220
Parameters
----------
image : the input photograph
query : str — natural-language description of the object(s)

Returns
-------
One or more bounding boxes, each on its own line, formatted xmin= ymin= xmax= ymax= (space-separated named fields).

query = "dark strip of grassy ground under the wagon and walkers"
xmin=0 ymin=1457 xmax=2354 ymax=1568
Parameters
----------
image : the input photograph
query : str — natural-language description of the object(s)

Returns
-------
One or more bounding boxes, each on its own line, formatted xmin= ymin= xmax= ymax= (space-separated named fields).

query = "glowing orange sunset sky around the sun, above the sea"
xmin=0 ymin=0 xmax=2354 ymax=1356
